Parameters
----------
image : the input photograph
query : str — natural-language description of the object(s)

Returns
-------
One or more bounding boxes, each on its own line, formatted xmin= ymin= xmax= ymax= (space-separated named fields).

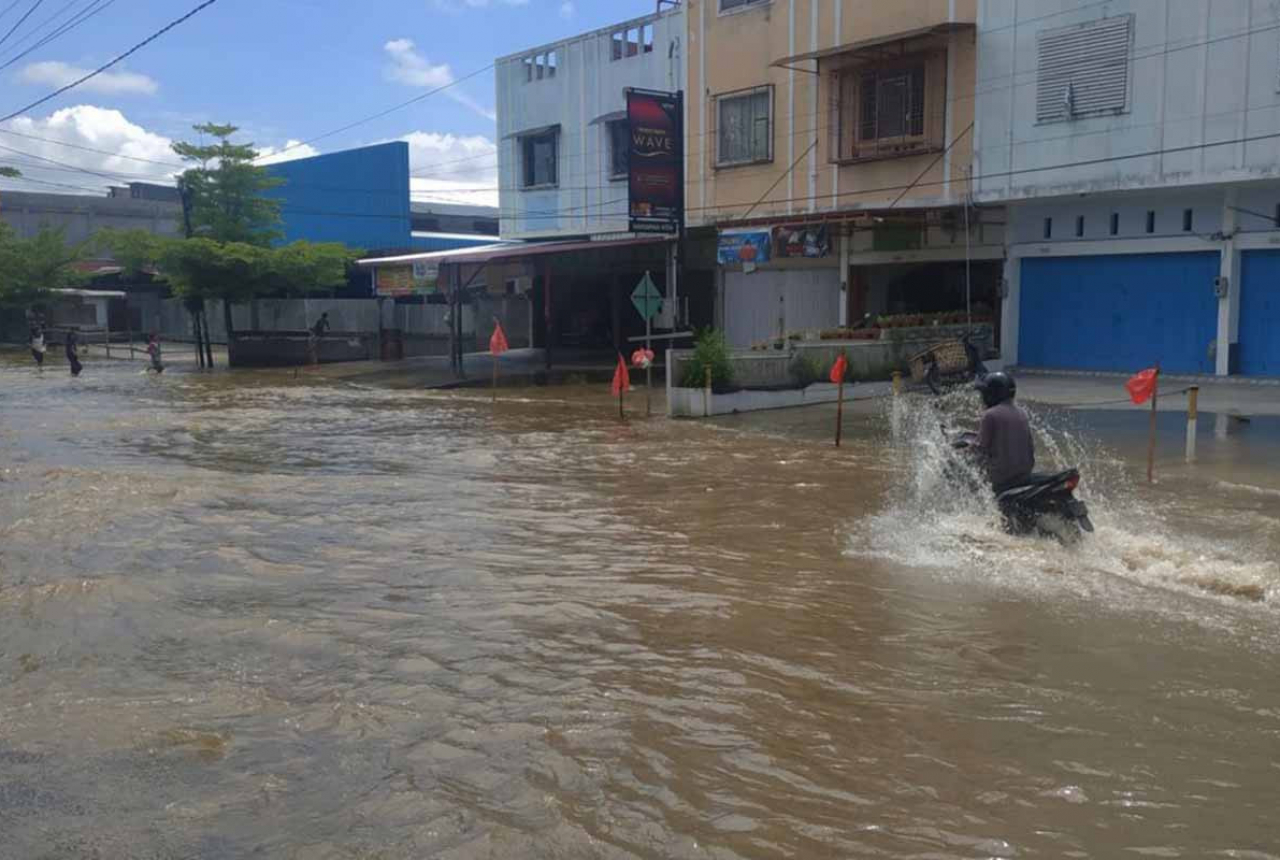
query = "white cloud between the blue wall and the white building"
xmin=402 ymin=132 xmax=498 ymax=206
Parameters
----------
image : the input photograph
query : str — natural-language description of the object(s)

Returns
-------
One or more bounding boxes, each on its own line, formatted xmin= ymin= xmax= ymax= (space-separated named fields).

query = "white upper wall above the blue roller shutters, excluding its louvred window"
xmin=974 ymin=0 xmax=1280 ymax=201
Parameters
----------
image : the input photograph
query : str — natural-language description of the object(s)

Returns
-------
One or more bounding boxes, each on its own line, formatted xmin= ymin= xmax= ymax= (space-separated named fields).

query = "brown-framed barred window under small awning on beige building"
xmin=829 ymin=54 xmax=946 ymax=161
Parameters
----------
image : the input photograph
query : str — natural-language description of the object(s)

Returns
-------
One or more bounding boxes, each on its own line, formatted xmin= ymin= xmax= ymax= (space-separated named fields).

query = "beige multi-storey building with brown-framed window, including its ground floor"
xmin=686 ymin=0 xmax=1004 ymax=346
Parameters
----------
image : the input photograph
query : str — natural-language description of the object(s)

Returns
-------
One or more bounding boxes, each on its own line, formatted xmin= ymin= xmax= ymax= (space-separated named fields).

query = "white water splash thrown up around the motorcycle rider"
xmin=845 ymin=392 xmax=1280 ymax=605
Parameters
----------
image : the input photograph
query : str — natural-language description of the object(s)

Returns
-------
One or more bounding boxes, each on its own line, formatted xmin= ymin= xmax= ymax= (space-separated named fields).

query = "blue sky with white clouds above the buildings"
xmin=0 ymin=0 xmax=655 ymax=202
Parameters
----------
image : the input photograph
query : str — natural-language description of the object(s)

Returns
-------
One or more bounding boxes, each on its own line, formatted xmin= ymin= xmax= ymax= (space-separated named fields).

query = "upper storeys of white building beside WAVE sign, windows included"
xmin=495 ymin=4 xmax=685 ymax=239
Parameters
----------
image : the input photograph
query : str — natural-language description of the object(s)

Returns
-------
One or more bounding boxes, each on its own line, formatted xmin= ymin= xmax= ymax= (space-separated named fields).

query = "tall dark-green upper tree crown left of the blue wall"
xmin=173 ymin=123 xmax=284 ymax=246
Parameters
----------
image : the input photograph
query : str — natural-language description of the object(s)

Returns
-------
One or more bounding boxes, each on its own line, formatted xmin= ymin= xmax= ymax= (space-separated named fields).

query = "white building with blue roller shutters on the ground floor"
xmin=974 ymin=0 xmax=1280 ymax=376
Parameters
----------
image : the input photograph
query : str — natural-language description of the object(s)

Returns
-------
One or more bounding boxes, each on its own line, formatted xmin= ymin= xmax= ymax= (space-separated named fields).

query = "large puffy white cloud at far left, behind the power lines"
xmin=0 ymin=105 xmax=180 ymax=193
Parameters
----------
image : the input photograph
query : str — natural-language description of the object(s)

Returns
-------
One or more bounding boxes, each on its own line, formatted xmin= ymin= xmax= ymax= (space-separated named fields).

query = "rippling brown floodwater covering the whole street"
xmin=0 ymin=353 xmax=1280 ymax=860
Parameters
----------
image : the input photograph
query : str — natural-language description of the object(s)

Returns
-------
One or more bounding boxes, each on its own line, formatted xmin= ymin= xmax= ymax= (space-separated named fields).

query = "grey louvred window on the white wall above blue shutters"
xmin=1036 ymin=15 xmax=1133 ymax=123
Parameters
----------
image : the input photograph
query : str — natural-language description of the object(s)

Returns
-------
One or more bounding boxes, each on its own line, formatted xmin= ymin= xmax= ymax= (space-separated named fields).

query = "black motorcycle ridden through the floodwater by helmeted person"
xmin=952 ymin=433 xmax=1093 ymax=544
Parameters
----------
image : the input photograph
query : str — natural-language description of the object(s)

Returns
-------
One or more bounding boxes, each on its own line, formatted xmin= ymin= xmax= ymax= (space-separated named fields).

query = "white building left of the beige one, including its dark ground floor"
xmin=494 ymin=0 xmax=710 ymax=349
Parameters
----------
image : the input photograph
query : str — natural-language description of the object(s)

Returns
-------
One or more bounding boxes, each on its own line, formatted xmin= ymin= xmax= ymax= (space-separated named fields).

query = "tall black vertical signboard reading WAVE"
xmin=627 ymin=90 xmax=685 ymax=233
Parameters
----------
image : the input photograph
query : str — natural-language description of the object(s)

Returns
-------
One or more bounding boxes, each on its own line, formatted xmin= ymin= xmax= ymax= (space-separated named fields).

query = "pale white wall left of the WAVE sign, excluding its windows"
xmin=495 ymin=5 xmax=685 ymax=238
